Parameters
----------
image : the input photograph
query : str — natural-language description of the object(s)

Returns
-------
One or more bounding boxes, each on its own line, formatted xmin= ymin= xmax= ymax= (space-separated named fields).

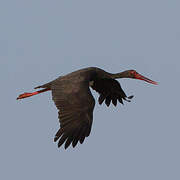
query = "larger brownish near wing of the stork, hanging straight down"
xmin=51 ymin=81 xmax=95 ymax=149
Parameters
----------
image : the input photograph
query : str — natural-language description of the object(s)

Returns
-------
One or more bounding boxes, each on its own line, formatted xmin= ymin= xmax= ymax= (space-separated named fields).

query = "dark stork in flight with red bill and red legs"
xmin=17 ymin=67 xmax=157 ymax=149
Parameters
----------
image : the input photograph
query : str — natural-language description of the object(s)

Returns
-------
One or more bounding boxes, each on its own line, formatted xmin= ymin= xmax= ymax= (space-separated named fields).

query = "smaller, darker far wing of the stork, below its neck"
xmin=91 ymin=78 xmax=133 ymax=106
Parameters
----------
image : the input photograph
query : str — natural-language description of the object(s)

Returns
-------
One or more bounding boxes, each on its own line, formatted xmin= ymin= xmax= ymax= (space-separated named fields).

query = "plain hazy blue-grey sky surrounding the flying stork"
xmin=0 ymin=0 xmax=180 ymax=180
